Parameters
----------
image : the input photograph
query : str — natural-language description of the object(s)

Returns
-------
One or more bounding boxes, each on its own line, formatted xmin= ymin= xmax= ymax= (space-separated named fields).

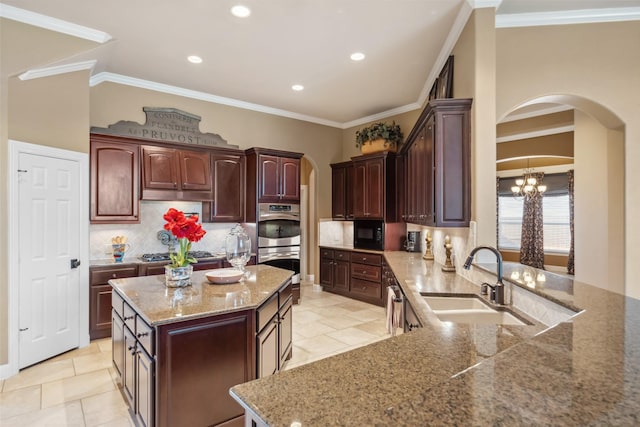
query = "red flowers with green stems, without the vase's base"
xmin=163 ymin=208 xmax=207 ymax=267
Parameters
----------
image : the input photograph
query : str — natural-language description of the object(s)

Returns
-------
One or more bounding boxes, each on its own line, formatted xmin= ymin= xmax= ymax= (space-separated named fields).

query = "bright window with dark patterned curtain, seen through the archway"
xmin=498 ymin=174 xmax=571 ymax=254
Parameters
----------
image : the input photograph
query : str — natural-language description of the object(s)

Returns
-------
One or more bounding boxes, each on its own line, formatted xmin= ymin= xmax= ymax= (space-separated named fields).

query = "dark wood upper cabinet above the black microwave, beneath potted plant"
xmin=352 ymin=151 xmax=396 ymax=222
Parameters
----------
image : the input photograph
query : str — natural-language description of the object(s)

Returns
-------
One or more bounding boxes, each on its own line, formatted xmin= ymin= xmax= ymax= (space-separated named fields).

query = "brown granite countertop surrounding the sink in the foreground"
xmin=231 ymin=252 xmax=640 ymax=426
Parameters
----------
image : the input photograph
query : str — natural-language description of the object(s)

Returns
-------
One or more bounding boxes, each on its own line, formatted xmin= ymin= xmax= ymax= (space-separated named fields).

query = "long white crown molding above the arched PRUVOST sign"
xmin=89 ymin=72 xmax=342 ymax=128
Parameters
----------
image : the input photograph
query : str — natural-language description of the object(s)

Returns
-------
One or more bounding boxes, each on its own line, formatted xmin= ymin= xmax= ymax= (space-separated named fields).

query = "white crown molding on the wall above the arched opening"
xmin=496 ymin=7 xmax=640 ymax=28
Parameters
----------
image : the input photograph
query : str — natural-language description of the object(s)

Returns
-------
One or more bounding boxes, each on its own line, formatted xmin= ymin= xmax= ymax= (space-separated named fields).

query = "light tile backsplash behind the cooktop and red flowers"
xmin=89 ymin=201 xmax=235 ymax=260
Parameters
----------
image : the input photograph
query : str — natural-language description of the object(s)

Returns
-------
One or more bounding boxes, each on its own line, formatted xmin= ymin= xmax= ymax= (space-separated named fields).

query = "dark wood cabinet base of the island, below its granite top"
xmin=111 ymin=281 xmax=293 ymax=427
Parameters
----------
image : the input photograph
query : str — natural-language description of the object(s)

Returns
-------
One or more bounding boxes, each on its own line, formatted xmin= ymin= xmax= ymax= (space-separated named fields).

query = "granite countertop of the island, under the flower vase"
xmin=109 ymin=264 xmax=293 ymax=326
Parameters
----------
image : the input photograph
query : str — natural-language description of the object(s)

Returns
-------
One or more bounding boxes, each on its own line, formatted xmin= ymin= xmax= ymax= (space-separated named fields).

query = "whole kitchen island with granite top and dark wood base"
xmin=109 ymin=265 xmax=293 ymax=426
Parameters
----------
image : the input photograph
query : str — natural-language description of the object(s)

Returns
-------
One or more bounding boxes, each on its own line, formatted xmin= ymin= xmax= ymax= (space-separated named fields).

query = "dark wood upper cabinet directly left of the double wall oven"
xmin=202 ymin=152 xmax=245 ymax=222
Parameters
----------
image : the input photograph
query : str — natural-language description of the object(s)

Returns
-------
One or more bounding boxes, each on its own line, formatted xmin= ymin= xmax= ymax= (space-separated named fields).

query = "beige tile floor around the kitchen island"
xmin=0 ymin=284 xmax=388 ymax=427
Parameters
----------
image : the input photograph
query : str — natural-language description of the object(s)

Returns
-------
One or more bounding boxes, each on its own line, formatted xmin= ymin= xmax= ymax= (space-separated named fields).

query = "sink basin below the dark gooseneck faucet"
xmin=423 ymin=294 xmax=529 ymax=325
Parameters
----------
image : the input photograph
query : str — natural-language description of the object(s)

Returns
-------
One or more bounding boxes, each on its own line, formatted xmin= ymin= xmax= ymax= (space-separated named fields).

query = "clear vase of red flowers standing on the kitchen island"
xmin=163 ymin=208 xmax=207 ymax=288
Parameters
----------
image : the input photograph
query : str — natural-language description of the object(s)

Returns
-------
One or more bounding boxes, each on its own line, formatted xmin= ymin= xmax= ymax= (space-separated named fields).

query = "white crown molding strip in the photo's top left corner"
xmin=0 ymin=3 xmax=111 ymax=43
